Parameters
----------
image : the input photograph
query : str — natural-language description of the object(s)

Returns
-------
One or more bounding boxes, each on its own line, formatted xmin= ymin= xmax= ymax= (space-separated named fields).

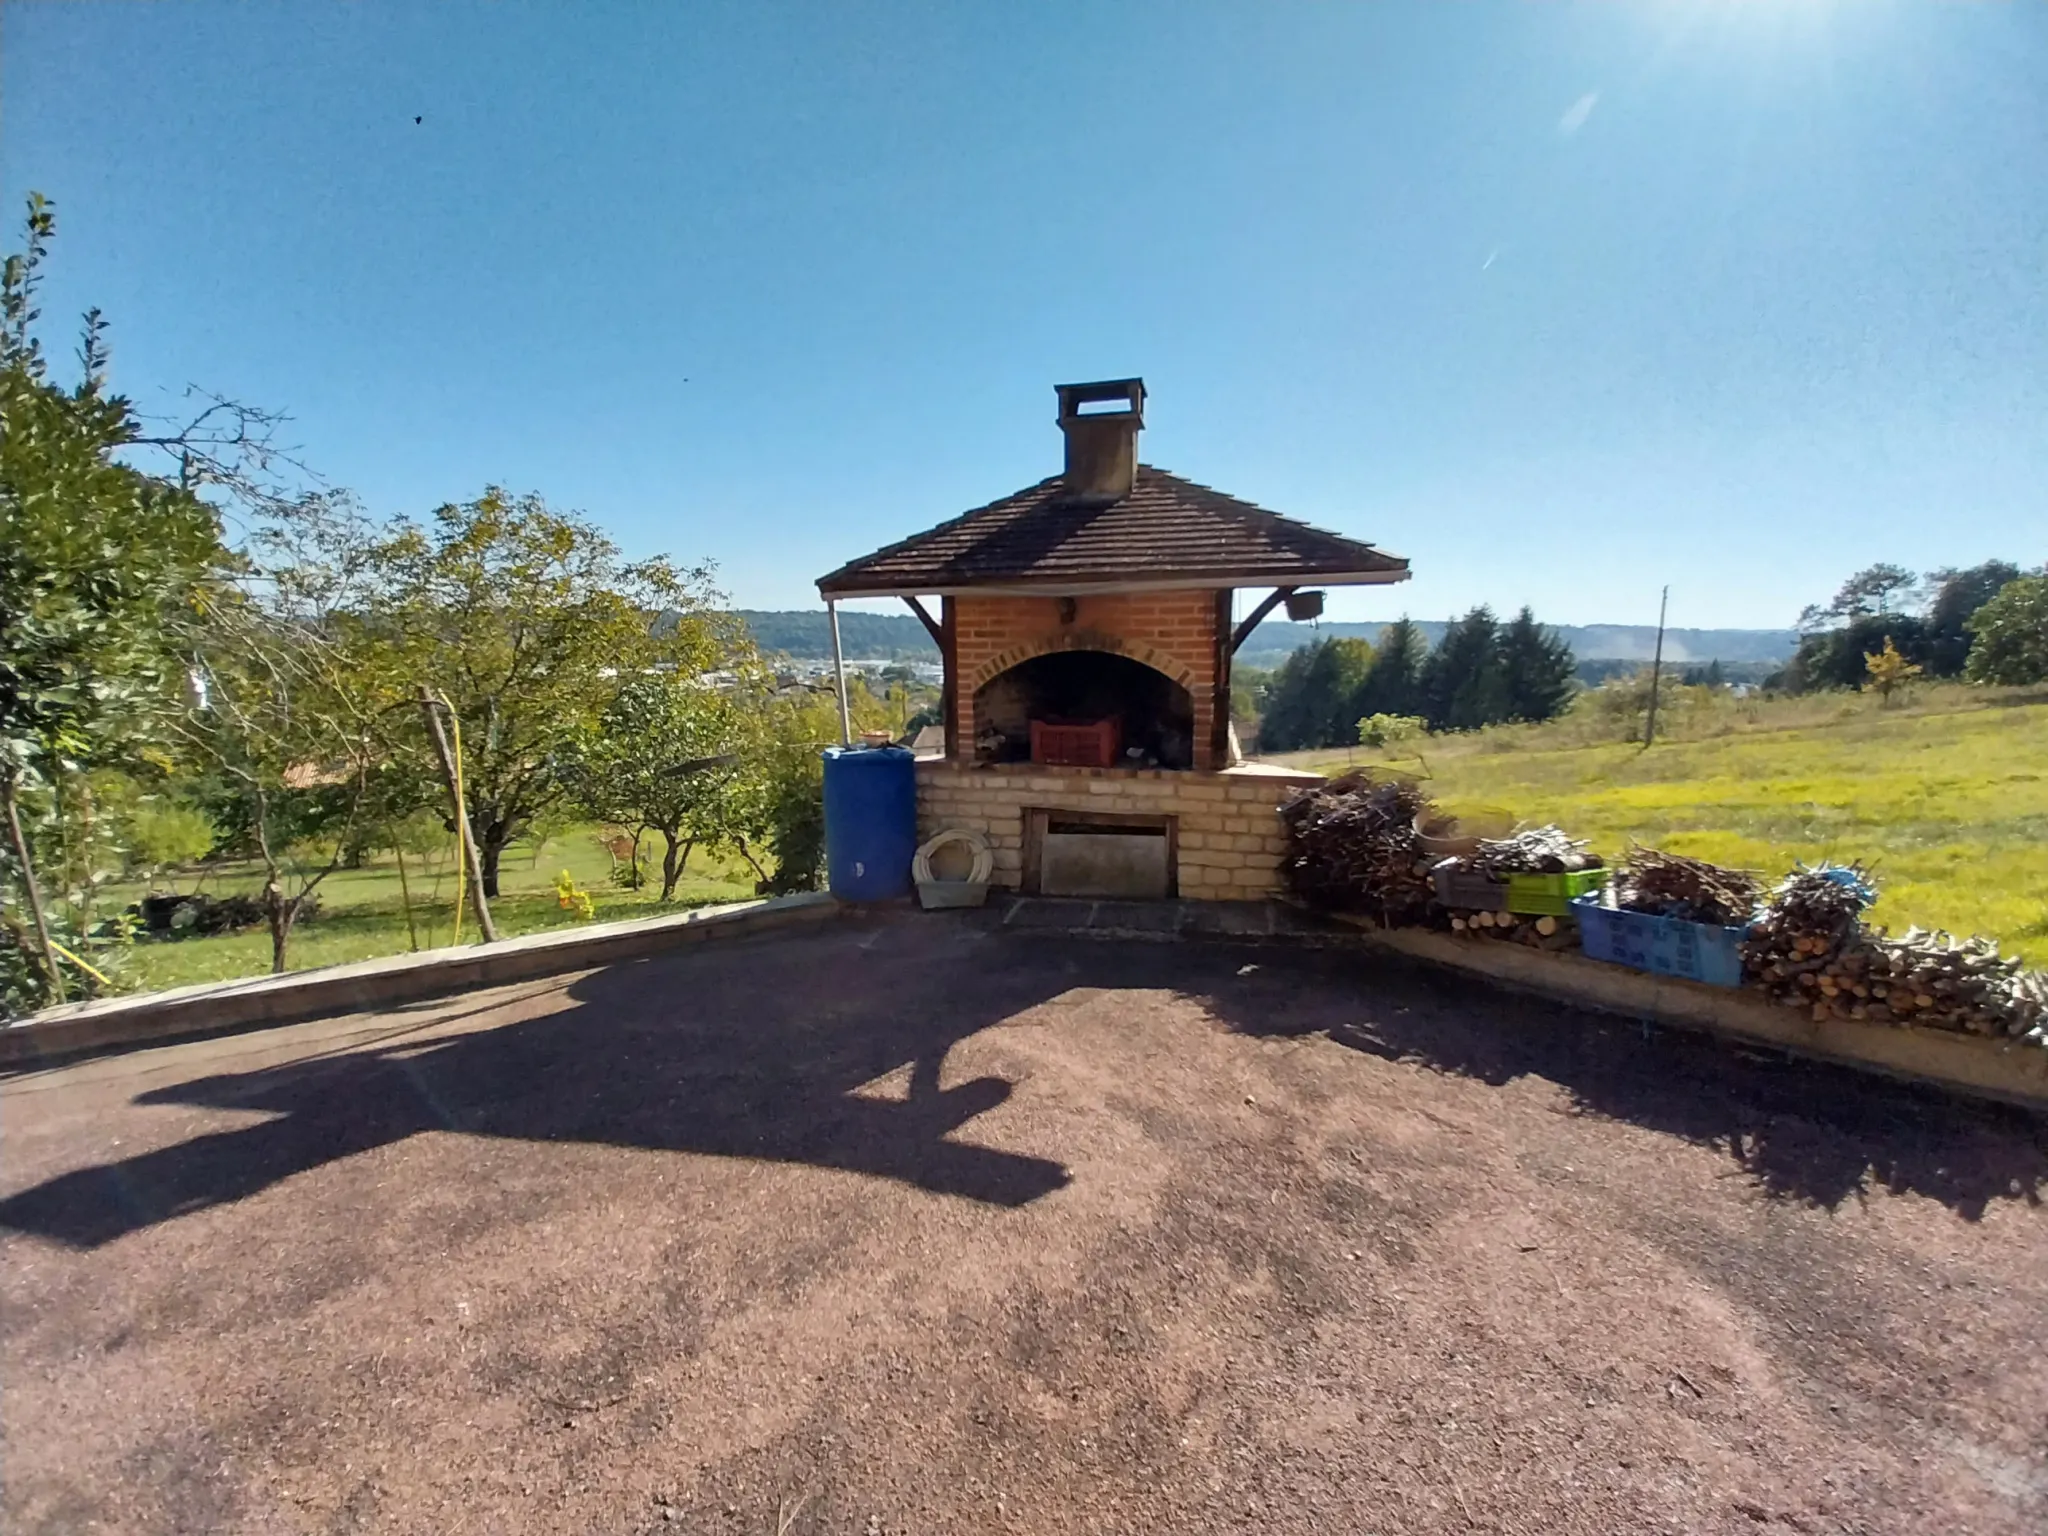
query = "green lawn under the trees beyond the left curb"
xmin=106 ymin=827 xmax=754 ymax=991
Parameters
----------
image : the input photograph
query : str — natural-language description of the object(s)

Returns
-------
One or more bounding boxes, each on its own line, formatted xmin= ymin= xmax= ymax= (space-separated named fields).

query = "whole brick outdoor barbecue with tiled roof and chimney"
xmin=817 ymin=379 xmax=1409 ymax=899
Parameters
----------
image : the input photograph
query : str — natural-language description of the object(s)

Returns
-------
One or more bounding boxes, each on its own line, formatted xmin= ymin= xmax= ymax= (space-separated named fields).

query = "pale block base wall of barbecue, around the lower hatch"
xmin=918 ymin=760 xmax=1321 ymax=901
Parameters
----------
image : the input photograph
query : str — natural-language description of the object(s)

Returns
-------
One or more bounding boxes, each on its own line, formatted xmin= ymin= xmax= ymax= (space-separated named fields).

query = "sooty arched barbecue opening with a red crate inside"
xmin=975 ymin=651 xmax=1194 ymax=768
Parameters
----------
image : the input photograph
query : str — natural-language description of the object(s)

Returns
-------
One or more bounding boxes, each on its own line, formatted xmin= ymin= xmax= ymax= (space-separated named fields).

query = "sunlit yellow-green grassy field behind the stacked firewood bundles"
xmin=1300 ymin=688 xmax=2048 ymax=965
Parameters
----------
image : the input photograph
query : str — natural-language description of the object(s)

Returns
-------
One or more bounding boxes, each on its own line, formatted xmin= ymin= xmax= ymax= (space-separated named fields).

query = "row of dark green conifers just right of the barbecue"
xmin=1255 ymin=606 xmax=1577 ymax=752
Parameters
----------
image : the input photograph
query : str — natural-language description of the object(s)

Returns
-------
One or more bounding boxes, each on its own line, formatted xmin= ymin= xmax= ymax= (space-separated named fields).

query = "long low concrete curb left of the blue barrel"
xmin=0 ymin=891 xmax=846 ymax=1073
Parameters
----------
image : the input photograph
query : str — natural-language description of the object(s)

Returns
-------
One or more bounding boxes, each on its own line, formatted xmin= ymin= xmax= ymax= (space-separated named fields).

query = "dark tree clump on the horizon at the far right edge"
xmin=1769 ymin=559 xmax=2048 ymax=692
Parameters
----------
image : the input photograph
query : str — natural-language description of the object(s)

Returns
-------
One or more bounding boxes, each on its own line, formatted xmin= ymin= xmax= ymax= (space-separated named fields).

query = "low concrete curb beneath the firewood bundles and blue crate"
xmin=1327 ymin=926 xmax=2048 ymax=1112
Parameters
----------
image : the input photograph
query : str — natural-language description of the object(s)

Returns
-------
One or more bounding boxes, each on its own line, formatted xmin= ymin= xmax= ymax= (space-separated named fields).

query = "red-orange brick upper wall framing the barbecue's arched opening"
xmin=950 ymin=590 xmax=1223 ymax=768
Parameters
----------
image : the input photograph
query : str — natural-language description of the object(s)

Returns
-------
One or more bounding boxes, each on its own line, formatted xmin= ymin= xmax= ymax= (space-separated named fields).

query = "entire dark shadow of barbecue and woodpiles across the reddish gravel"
xmin=0 ymin=918 xmax=2048 ymax=1247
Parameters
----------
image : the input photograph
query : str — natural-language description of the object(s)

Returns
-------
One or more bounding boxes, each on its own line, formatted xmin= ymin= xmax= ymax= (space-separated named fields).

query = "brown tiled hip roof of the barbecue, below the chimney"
xmin=817 ymin=465 xmax=1409 ymax=598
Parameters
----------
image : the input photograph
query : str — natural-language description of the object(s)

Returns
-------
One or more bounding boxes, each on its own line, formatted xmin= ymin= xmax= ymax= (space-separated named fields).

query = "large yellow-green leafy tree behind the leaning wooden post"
xmin=375 ymin=487 xmax=743 ymax=897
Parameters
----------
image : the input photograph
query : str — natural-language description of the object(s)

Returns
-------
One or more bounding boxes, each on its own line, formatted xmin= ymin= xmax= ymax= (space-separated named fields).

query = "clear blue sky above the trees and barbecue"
xmin=0 ymin=0 xmax=2048 ymax=625
